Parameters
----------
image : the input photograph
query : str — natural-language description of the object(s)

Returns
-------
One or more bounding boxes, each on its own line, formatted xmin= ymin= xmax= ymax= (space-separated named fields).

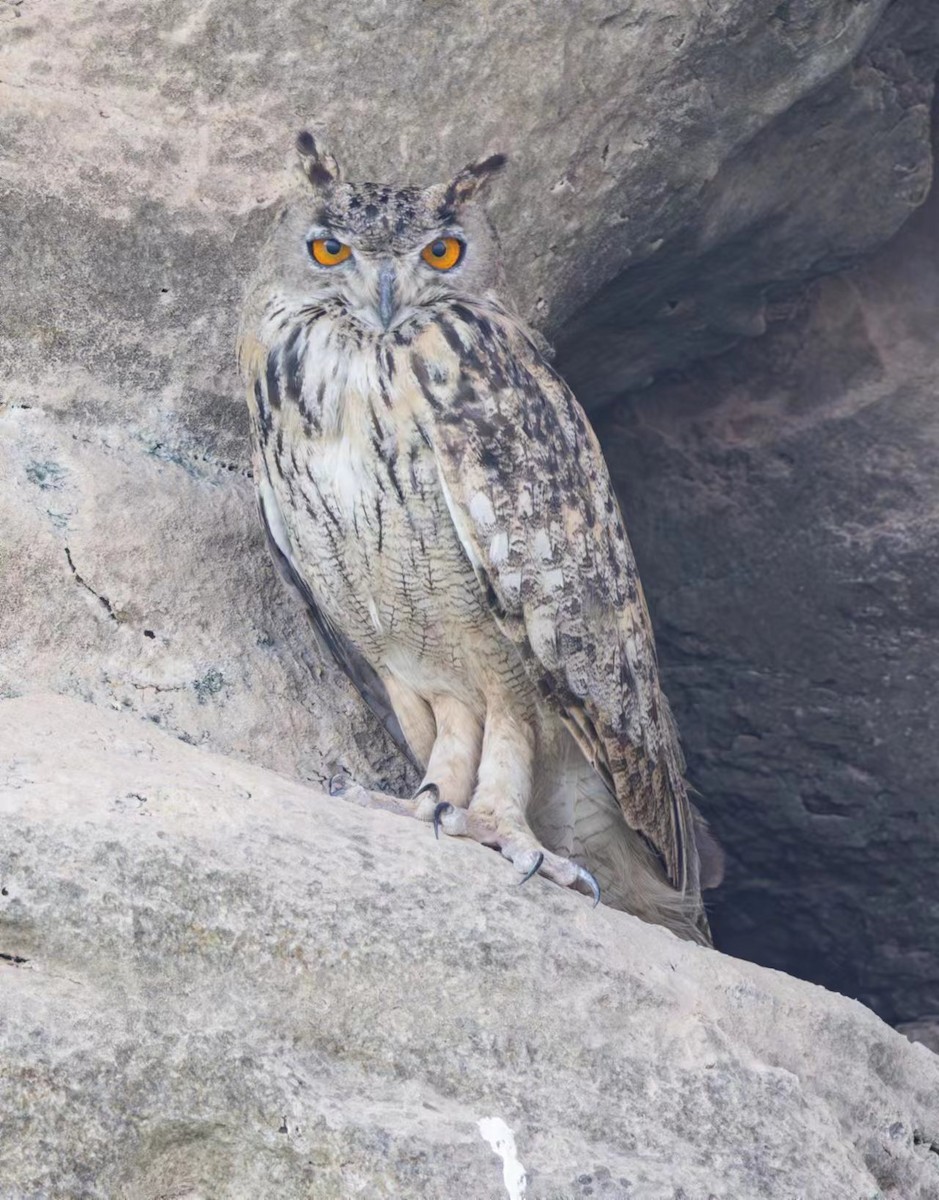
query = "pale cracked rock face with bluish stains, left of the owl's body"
xmin=0 ymin=404 xmax=413 ymax=801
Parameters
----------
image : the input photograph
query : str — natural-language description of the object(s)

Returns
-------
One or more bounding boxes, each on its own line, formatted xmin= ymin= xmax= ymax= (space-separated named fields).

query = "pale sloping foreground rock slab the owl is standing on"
xmin=0 ymin=696 xmax=939 ymax=1200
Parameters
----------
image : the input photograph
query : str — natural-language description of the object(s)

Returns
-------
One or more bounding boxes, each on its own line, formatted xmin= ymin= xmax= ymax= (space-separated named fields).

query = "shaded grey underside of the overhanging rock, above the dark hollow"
xmin=558 ymin=0 xmax=939 ymax=409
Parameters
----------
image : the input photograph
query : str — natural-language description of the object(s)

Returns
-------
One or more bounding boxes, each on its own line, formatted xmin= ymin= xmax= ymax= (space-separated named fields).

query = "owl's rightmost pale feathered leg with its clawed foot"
xmin=433 ymin=712 xmax=600 ymax=902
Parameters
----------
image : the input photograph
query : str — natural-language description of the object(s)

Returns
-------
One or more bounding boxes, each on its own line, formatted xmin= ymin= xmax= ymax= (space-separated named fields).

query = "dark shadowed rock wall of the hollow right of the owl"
xmin=598 ymin=110 xmax=939 ymax=1022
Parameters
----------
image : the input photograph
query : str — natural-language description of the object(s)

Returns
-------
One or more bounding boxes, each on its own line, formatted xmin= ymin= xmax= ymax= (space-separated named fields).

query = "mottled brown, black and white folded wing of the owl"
xmin=420 ymin=305 xmax=698 ymax=892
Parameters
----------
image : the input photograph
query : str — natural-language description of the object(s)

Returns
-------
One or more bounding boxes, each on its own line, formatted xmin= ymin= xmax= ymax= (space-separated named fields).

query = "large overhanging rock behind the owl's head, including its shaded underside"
xmin=0 ymin=0 xmax=931 ymax=388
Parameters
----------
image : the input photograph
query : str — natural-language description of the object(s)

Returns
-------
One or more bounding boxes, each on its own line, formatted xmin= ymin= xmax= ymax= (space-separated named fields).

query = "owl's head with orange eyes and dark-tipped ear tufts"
xmin=260 ymin=133 xmax=506 ymax=335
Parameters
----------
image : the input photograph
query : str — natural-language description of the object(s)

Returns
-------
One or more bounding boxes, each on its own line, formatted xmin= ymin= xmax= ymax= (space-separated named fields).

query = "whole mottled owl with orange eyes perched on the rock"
xmin=239 ymin=133 xmax=718 ymax=943
